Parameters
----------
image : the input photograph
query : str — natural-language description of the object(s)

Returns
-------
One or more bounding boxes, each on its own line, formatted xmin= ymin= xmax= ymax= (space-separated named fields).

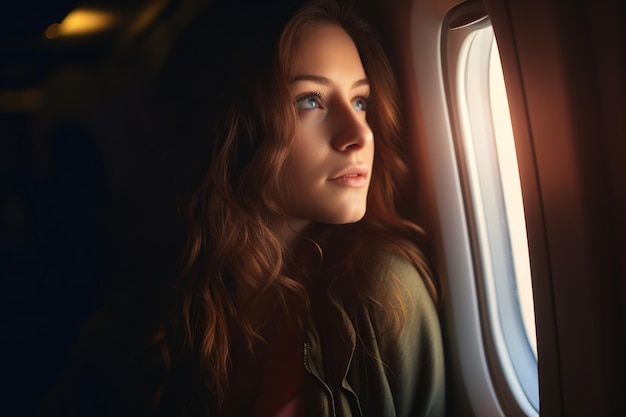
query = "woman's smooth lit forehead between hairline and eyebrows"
xmin=294 ymin=23 xmax=365 ymax=78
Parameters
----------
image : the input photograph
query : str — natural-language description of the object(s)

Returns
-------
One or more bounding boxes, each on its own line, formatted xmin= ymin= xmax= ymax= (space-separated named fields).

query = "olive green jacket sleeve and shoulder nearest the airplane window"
xmin=379 ymin=257 xmax=445 ymax=417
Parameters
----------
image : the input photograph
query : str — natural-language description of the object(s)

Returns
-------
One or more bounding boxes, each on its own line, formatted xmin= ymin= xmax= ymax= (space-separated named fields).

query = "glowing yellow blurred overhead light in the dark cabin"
xmin=45 ymin=8 xmax=117 ymax=39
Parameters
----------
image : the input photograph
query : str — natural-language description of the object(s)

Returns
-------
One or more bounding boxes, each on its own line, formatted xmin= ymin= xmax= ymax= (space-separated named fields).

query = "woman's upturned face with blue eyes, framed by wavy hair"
xmin=284 ymin=23 xmax=374 ymax=230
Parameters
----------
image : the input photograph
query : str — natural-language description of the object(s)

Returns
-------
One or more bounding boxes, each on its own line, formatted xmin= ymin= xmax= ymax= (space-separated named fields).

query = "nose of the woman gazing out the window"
xmin=331 ymin=101 xmax=374 ymax=152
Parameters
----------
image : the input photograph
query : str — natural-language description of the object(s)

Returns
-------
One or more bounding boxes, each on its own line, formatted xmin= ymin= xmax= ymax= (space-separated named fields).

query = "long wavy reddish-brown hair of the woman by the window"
xmin=155 ymin=0 xmax=438 ymax=408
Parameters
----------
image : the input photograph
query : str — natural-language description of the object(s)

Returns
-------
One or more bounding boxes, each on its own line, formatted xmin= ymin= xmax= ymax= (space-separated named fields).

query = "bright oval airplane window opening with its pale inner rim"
xmin=444 ymin=11 xmax=539 ymax=415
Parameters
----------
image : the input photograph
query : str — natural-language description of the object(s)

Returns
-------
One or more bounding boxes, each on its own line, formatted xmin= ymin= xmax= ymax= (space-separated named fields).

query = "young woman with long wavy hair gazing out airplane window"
xmin=41 ymin=0 xmax=444 ymax=416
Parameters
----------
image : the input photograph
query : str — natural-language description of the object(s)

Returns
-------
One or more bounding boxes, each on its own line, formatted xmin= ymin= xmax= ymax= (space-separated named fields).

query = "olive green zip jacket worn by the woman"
xmin=304 ymin=254 xmax=445 ymax=417
